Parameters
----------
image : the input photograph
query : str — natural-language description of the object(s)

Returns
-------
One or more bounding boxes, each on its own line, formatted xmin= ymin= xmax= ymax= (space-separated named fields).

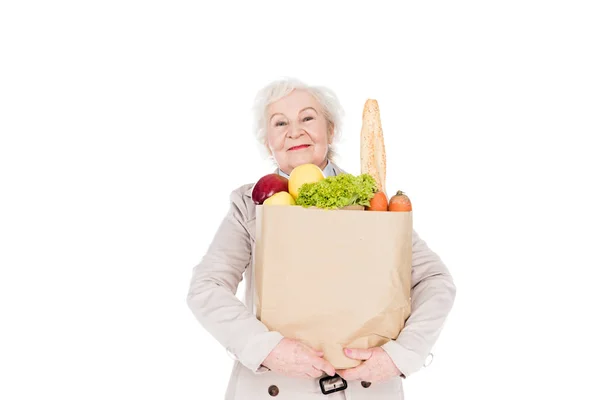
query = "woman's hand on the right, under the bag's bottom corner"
xmin=337 ymin=347 xmax=401 ymax=383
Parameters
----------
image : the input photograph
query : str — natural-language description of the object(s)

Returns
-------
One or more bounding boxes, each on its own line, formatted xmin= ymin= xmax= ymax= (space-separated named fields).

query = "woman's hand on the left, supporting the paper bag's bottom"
xmin=262 ymin=338 xmax=335 ymax=379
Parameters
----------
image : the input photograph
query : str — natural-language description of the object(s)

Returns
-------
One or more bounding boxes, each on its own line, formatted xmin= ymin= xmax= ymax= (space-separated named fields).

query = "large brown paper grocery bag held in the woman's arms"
xmin=254 ymin=206 xmax=412 ymax=369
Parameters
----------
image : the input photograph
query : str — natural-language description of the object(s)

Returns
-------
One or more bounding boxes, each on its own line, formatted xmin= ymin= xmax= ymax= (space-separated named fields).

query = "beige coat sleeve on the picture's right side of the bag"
xmin=382 ymin=231 xmax=456 ymax=377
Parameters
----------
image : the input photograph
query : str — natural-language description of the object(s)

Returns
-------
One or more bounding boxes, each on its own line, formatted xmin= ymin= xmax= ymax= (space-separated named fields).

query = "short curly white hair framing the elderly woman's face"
xmin=253 ymin=78 xmax=344 ymax=161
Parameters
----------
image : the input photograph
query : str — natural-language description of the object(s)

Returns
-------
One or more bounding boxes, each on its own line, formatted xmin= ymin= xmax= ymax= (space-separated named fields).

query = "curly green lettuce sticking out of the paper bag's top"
xmin=296 ymin=174 xmax=377 ymax=209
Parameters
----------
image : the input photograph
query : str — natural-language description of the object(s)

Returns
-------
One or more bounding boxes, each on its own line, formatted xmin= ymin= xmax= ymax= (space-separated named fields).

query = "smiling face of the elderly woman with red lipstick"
xmin=267 ymin=90 xmax=333 ymax=174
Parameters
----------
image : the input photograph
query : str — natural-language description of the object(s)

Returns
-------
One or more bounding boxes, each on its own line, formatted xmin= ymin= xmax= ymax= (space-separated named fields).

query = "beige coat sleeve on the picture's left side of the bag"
xmin=187 ymin=192 xmax=283 ymax=373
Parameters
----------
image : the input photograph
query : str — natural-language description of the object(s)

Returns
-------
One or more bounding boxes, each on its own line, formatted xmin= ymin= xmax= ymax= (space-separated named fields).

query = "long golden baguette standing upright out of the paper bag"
xmin=360 ymin=99 xmax=387 ymax=196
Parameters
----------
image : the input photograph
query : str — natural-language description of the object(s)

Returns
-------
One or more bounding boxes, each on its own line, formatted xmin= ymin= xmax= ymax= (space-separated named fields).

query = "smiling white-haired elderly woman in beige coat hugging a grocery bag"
xmin=187 ymin=79 xmax=455 ymax=400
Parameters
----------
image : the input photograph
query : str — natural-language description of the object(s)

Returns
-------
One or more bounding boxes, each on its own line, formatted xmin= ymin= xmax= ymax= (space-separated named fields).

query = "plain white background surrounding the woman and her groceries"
xmin=0 ymin=0 xmax=600 ymax=400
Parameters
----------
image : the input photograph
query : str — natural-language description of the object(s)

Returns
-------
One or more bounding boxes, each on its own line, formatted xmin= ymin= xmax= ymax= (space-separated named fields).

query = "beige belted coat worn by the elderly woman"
xmin=187 ymin=163 xmax=456 ymax=400
